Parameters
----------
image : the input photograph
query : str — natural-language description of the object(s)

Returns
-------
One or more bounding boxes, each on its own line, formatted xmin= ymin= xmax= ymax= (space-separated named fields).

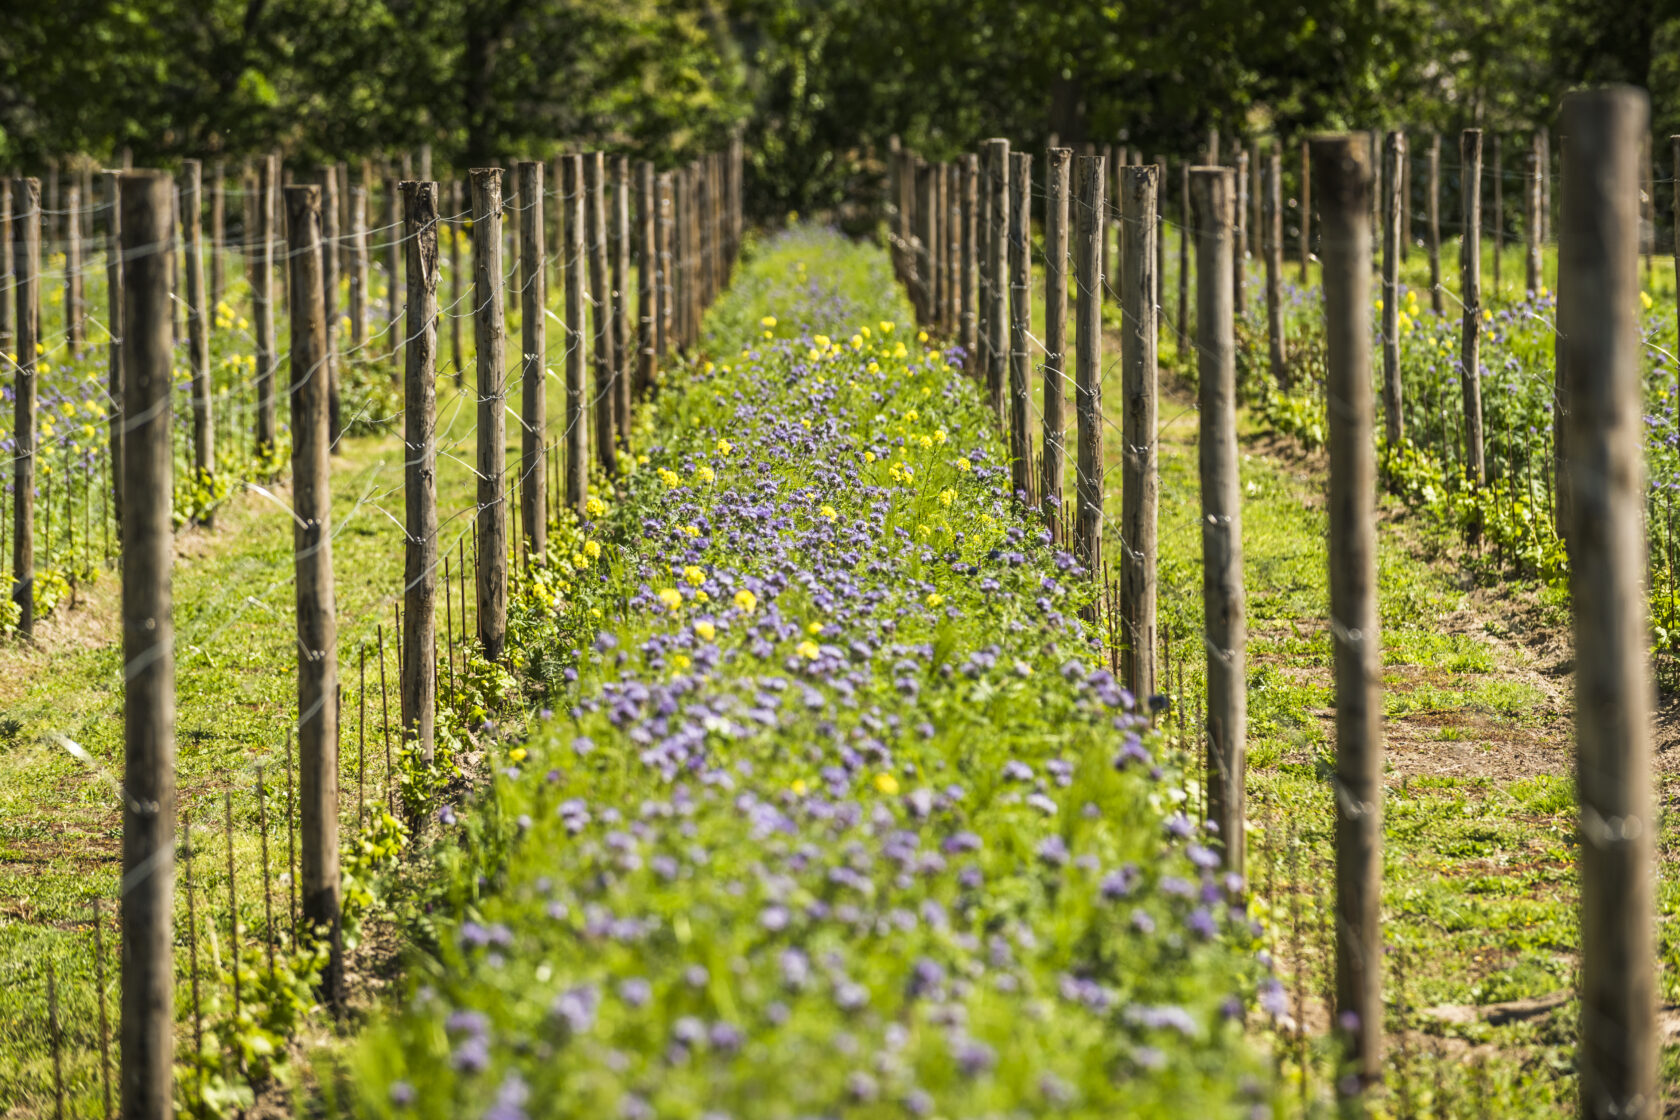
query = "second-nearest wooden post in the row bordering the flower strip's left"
xmin=286 ymin=186 xmax=344 ymax=1007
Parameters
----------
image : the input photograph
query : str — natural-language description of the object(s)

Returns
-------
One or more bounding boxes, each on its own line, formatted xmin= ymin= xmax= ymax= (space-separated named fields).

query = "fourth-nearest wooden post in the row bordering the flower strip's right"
xmin=1121 ymin=156 xmax=1162 ymax=700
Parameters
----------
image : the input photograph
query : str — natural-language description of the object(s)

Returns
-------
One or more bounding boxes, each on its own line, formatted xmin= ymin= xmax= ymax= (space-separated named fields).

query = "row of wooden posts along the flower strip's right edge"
xmin=890 ymin=89 xmax=1658 ymax=1117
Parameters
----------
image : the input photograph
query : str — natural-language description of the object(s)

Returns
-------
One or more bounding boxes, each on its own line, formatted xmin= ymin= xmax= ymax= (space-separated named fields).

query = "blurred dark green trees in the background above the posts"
xmin=0 ymin=0 xmax=1680 ymax=213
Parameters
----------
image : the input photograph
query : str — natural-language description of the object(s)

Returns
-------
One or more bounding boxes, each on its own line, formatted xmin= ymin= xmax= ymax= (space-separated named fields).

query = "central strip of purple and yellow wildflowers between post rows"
xmin=348 ymin=230 xmax=1277 ymax=1120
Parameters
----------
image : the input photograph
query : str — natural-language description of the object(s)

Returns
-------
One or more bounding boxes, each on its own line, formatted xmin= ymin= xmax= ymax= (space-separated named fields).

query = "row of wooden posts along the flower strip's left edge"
xmin=78 ymin=146 xmax=743 ymax=1120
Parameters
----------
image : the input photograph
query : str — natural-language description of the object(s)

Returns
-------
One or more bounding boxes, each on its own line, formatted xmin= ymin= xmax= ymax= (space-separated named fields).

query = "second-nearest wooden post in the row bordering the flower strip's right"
xmin=1312 ymin=134 xmax=1383 ymax=1091
